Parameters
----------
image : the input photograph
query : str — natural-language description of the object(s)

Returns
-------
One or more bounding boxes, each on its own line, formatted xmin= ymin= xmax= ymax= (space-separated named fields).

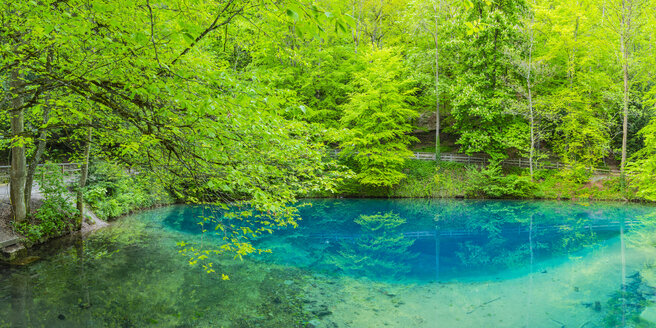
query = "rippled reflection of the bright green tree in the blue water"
xmin=331 ymin=212 xmax=414 ymax=277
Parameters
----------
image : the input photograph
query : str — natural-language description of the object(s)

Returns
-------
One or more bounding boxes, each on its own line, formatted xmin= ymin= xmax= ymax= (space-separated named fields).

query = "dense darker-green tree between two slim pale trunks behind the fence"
xmin=446 ymin=1 xmax=528 ymax=159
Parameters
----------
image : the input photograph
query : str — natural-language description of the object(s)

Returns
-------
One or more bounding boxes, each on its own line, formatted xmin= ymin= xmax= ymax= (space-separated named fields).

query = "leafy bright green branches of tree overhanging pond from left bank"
xmin=0 ymin=0 xmax=344 ymax=262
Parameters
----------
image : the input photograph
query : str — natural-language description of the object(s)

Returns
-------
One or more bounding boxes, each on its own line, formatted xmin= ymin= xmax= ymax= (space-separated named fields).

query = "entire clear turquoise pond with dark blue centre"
xmin=0 ymin=199 xmax=656 ymax=328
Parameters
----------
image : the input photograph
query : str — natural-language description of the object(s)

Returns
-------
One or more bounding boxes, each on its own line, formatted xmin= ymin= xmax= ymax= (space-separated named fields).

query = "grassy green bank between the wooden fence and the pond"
xmin=328 ymin=160 xmax=639 ymax=201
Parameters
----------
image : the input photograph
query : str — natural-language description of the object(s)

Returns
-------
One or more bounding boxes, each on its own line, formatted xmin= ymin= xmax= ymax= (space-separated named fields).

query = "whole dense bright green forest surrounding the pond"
xmin=0 ymin=0 xmax=656 ymax=254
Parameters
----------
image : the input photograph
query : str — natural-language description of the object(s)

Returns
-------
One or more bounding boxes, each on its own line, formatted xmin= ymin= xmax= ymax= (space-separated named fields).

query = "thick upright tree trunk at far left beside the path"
xmin=9 ymin=68 xmax=27 ymax=223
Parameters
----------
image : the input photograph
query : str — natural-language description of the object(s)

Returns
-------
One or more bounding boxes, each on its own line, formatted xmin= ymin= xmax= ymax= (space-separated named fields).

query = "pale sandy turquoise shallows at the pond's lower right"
xmin=300 ymin=240 xmax=656 ymax=327
